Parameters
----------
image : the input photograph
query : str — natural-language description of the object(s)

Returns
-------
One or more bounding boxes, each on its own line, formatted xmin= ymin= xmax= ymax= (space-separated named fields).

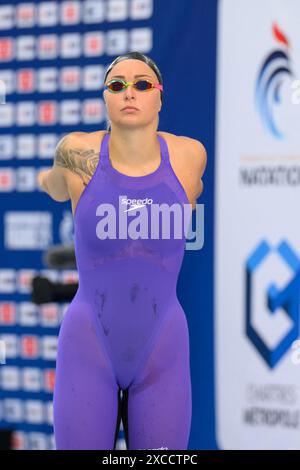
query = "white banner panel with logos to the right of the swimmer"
xmin=214 ymin=0 xmax=300 ymax=449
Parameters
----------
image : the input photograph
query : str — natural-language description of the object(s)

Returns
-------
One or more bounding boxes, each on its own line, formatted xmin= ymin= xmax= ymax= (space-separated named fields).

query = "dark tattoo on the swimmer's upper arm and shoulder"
xmin=54 ymin=136 xmax=99 ymax=186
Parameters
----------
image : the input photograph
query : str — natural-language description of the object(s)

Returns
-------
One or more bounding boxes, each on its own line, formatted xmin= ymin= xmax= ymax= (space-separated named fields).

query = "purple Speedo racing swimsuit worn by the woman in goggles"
xmin=53 ymin=133 xmax=192 ymax=450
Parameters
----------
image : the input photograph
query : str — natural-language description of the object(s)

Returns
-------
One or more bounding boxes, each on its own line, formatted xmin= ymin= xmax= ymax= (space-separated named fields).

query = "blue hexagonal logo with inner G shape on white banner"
xmin=245 ymin=240 xmax=300 ymax=368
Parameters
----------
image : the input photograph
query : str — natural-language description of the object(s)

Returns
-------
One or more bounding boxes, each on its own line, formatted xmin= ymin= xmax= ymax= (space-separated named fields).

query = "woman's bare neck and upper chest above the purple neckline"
xmin=109 ymin=127 xmax=160 ymax=168
